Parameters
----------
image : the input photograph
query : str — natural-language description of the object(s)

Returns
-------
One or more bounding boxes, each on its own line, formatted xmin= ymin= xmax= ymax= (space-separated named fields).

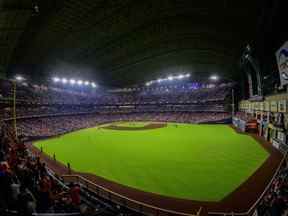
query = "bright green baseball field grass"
xmin=35 ymin=122 xmax=269 ymax=201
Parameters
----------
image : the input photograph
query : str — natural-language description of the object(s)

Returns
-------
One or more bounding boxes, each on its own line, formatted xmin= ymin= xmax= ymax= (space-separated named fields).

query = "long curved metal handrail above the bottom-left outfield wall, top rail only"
xmin=62 ymin=174 xmax=202 ymax=216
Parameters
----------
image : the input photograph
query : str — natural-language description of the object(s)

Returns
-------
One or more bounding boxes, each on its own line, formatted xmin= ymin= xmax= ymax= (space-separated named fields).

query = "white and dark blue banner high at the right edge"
xmin=276 ymin=41 xmax=288 ymax=86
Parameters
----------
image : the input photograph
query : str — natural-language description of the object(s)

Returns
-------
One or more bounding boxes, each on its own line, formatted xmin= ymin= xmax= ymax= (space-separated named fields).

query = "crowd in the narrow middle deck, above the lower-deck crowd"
xmin=0 ymin=103 xmax=224 ymax=119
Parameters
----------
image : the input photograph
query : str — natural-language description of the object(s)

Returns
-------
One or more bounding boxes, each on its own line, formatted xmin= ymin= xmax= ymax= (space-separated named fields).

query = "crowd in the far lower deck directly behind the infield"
xmin=17 ymin=112 xmax=230 ymax=137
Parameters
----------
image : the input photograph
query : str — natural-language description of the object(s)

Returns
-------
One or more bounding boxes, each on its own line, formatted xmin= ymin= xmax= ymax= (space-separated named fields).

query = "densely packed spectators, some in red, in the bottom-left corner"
xmin=0 ymin=124 xmax=81 ymax=216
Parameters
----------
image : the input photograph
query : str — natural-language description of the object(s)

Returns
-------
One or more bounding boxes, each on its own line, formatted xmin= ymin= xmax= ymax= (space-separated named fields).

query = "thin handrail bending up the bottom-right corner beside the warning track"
xmin=208 ymin=152 xmax=288 ymax=216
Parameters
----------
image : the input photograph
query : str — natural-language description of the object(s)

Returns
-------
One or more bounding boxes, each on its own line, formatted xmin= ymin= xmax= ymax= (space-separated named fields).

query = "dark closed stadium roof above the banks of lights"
xmin=0 ymin=0 xmax=286 ymax=86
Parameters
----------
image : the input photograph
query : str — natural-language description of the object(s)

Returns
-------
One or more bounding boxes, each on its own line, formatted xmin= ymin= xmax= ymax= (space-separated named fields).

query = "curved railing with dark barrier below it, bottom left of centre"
xmin=62 ymin=175 xmax=202 ymax=216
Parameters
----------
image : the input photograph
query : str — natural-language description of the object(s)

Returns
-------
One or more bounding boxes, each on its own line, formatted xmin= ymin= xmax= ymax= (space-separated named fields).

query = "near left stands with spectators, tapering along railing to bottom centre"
xmin=0 ymin=121 xmax=142 ymax=216
